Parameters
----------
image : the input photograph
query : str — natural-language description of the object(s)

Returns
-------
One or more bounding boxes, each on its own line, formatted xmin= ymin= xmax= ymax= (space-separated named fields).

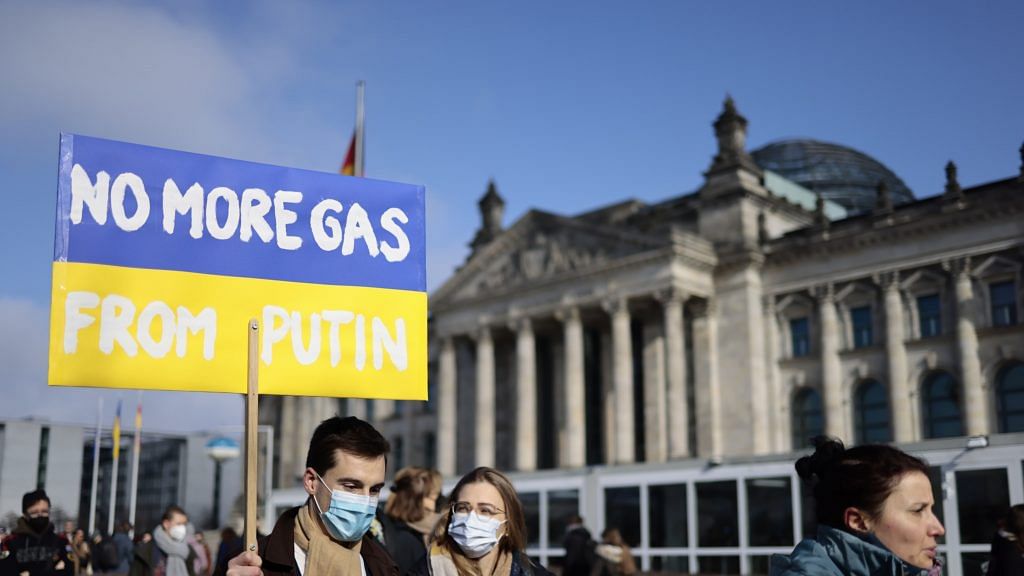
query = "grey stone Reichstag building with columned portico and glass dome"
xmin=264 ymin=99 xmax=1024 ymax=574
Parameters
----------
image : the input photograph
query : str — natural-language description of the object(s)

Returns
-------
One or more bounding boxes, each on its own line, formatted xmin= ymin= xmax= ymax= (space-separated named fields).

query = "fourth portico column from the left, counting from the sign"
xmin=556 ymin=306 xmax=587 ymax=468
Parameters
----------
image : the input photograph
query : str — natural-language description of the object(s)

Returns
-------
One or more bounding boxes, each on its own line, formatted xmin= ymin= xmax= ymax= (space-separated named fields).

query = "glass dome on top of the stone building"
xmin=751 ymin=139 xmax=913 ymax=214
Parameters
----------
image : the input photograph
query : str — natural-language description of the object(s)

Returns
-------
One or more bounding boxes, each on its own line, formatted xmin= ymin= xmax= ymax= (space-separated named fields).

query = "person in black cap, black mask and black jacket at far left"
xmin=0 ymin=490 xmax=75 ymax=576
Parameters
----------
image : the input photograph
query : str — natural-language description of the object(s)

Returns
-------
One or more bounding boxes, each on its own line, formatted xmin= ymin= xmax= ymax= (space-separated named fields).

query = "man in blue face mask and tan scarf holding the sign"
xmin=227 ymin=416 xmax=398 ymax=576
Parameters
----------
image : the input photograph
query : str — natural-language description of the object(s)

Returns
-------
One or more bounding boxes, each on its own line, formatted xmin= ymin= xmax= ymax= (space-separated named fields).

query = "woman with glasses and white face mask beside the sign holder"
xmin=417 ymin=467 xmax=550 ymax=576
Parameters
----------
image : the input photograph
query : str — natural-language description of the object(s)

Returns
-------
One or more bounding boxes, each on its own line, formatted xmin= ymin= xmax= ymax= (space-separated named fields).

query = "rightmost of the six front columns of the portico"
xmin=660 ymin=290 xmax=690 ymax=459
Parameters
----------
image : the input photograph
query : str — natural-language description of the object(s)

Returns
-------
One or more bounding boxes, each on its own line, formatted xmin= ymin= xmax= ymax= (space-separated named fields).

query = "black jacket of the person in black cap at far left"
xmin=0 ymin=518 xmax=75 ymax=576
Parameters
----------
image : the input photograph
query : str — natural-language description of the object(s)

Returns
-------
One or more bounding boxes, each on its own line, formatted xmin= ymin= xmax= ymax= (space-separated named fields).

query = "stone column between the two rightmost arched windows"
xmin=947 ymin=258 xmax=990 ymax=436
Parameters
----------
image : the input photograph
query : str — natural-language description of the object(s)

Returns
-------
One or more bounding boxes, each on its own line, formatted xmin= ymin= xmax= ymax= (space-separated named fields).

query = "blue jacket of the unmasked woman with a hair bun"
xmin=769 ymin=526 xmax=928 ymax=576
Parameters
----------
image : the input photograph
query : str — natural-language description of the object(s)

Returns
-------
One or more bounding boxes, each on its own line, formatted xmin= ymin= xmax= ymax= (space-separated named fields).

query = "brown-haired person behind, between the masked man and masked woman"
xmin=379 ymin=466 xmax=441 ymax=574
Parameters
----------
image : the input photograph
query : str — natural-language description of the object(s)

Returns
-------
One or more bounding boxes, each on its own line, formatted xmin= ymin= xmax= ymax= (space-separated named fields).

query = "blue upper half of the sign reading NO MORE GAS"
xmin=53 ymin=134 xmax=426 ymax=292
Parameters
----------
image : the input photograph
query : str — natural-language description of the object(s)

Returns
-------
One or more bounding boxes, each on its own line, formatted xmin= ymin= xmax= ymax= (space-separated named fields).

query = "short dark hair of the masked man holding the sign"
xmin=306 ymin=416 xmax=391 ymax=476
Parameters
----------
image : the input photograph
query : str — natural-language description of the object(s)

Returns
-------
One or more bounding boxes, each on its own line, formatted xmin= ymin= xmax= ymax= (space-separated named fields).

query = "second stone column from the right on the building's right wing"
xmin=881 ymin=272 xmax=918 ymax=443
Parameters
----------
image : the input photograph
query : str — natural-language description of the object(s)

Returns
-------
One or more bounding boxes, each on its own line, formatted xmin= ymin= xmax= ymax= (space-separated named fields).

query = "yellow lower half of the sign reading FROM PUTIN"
xmin=49 ymin=262 xmax=427 ymax=400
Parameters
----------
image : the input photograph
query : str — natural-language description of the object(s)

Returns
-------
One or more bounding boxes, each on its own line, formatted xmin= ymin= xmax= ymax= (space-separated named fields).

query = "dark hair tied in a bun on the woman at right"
xmin=797 ymin=436 xmax=928 ymax=530
